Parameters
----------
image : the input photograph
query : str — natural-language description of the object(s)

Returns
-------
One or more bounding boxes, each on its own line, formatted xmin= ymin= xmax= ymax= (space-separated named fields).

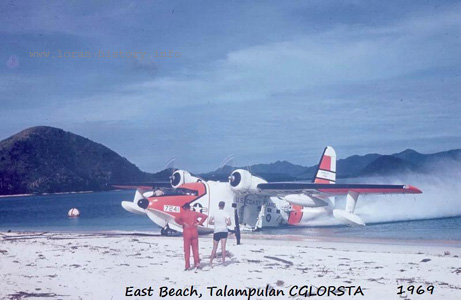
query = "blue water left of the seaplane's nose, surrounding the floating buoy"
xmin=0 ymin=190 xmax=156 ymax=232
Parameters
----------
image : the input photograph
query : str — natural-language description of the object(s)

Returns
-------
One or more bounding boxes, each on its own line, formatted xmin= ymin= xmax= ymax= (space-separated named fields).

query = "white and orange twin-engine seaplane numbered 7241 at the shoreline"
xmin=121 ymin=146 xmax=422 ymax=235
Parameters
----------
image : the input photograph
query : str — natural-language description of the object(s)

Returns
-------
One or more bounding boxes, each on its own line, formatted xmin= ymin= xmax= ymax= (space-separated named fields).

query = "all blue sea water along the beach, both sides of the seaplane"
xmin=0 ymin=190 xmax=461 ymax=241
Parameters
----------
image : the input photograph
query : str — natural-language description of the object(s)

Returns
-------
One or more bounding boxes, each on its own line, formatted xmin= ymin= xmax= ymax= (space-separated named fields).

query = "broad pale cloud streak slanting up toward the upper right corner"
xmin=122 ymin=4 xmax=461 ymax=108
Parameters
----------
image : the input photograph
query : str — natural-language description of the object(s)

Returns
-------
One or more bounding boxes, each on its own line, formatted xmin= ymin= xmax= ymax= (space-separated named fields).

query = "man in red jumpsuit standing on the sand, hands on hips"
xmin=174 ymin=203 xmax=208 ymax=270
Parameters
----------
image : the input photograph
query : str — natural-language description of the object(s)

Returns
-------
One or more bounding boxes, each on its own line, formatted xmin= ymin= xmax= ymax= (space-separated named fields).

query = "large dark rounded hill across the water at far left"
xmin=0 ymin=126 xmax=151 ymax=195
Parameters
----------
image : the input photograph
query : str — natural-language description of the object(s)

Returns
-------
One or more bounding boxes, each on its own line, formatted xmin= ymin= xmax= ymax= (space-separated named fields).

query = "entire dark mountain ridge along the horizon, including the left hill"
xmin=0 ymin=126 xmax=461 ymax=195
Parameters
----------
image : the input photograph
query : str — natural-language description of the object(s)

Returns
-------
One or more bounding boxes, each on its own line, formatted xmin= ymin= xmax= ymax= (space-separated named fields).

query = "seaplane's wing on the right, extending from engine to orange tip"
xmin=258 ymin=182 xmax=422 ymax=196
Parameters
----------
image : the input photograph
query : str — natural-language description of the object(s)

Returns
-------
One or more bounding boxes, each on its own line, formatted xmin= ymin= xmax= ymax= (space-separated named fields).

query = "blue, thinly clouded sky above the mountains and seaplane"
xmin=0 ymin=0 xmax=461 ymax=172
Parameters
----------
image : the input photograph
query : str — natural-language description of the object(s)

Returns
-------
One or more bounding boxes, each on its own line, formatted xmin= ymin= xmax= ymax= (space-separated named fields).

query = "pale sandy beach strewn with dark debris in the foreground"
xmin=0 ymin=232 xmax=461 ymax=300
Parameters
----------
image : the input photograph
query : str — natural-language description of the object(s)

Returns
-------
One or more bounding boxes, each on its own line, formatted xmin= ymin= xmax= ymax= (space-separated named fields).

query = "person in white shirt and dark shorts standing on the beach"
xmin=210 ymin=201 xmax=232 ymax=265
